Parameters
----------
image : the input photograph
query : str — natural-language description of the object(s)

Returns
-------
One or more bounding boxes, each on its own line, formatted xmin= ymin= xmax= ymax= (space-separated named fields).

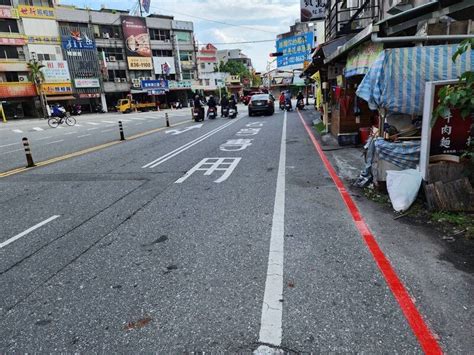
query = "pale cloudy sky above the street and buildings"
xmin=60 ymin=0 xmax=300 ymax=71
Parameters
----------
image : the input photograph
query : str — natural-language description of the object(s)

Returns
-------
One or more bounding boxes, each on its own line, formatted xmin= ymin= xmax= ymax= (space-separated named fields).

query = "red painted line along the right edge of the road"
xmin=298 ymin=111 xmax=443 ymax=354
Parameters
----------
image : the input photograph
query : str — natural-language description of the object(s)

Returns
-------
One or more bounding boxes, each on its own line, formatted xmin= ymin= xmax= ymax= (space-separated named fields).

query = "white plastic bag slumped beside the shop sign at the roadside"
xmin=387 ymin=169 xmax=422 ymax=212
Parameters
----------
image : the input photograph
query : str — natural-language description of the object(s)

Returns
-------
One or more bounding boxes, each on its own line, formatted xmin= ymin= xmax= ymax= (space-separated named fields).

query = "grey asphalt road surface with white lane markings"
xmin=0 ymin=105 xmax=473 ymax=353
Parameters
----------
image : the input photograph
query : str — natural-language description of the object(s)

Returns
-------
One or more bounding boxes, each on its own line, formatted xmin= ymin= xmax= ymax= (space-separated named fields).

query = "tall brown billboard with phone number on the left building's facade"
xmin=121 ymin=16 xmax=153 ymax=70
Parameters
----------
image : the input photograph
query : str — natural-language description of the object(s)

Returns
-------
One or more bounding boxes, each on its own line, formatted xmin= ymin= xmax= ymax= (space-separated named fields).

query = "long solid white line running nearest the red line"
xmin=257 ymin=112 xmax=287 ymax=351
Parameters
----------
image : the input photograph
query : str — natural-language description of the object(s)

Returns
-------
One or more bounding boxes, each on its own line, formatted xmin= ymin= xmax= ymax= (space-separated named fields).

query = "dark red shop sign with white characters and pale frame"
xmin=420 ymin=80 xmax=473 ymax=180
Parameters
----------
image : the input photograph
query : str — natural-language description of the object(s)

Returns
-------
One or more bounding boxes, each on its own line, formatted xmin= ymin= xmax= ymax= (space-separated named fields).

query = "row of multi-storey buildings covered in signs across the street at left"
xmin=0 ymin=0 xmax=198 ymax=118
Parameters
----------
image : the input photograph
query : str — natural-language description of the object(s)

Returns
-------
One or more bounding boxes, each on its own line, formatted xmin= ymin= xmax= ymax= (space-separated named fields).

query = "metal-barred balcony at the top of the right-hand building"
xmin=326 ymin=0 xmax=380 ymax=41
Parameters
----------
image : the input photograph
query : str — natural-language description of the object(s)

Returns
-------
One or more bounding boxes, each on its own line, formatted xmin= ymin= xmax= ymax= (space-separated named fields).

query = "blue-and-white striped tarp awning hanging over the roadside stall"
xmin=356 ymin=44 xmax=474 ymax=115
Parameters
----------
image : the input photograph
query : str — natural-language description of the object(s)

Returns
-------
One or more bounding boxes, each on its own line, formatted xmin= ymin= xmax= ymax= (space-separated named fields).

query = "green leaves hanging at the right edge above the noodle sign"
xmin=431 ymin=39 xmax=474 ymax=126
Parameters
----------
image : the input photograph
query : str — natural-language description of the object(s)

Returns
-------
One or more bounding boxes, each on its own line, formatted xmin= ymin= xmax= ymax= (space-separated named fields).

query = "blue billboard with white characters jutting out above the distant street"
xmin=276 ymin=32 xmax=314 ymax=68
